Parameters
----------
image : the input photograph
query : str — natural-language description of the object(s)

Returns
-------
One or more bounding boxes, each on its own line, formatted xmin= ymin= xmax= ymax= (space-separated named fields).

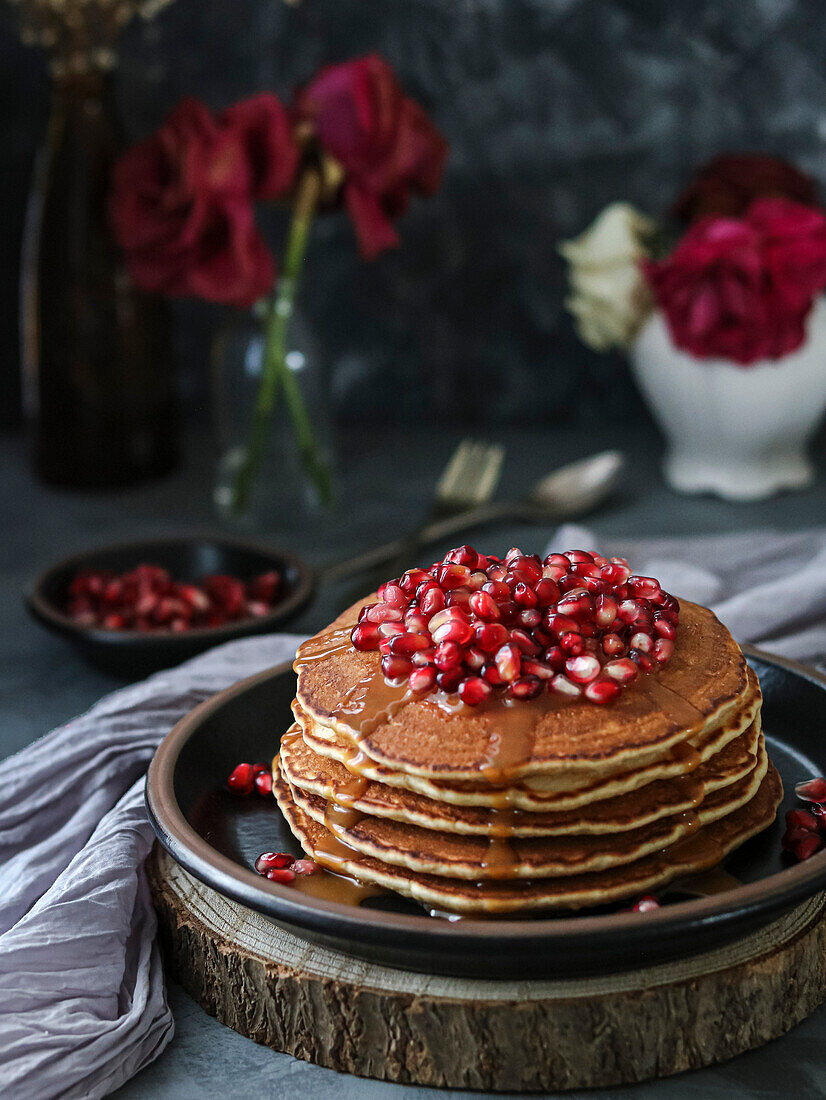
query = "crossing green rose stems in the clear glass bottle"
xmin=232 ymin=168 xmax=332 ymax=513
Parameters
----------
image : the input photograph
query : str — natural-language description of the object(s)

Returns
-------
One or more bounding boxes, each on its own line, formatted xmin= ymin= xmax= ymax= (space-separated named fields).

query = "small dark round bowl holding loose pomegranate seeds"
xmin=26 ymin=536 xmax=316 ymax=679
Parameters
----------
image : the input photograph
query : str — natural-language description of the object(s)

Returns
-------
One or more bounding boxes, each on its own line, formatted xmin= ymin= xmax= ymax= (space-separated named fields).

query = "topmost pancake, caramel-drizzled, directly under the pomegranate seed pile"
xmin=296 ymin=600 xmax=748 ymax=781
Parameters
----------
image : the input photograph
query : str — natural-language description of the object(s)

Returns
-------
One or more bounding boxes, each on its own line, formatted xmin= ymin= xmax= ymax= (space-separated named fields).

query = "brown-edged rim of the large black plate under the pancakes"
xmin=145 ymin=646 xmax=826 ymax=947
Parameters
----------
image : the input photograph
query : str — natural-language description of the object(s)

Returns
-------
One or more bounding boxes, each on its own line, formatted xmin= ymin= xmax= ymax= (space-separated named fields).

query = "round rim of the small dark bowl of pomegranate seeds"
xmin=25 ymin=534 xmax=316 ymax=648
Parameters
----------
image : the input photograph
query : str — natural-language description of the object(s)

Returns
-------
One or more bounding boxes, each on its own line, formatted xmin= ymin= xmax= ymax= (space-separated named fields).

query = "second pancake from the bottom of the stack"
xmin=279 ymin=745 xmax=769 ymax=882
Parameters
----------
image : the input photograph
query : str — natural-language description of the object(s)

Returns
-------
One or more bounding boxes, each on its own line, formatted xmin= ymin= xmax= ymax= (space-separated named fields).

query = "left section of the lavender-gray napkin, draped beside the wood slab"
xmin=0 ymin=635 xmax=300 ymax=1100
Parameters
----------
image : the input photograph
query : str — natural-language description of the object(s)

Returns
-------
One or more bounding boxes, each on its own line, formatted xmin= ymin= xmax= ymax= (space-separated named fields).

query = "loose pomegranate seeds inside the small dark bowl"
xmin=66 ymin=564 xmax=283 ymax=633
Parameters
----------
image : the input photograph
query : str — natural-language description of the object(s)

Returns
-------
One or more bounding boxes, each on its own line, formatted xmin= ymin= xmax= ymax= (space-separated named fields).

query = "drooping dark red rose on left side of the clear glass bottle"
xmin=111 ymin=97 xmax=297 ymax=307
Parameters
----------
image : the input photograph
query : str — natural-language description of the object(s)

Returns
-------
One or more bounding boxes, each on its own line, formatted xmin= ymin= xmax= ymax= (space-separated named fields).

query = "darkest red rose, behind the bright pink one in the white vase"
xmin=672 ymin=153 xmax=819 ymax=224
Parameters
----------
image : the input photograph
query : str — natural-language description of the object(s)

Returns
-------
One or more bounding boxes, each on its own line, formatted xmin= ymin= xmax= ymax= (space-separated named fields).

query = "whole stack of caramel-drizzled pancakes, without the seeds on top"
xmin=274 ymin=602 xmax=782 ymax=913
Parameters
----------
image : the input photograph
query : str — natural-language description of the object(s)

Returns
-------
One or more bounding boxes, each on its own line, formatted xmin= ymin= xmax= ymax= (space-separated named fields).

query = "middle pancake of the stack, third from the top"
xmin=280 ymin=718 xmax=760 ymax=836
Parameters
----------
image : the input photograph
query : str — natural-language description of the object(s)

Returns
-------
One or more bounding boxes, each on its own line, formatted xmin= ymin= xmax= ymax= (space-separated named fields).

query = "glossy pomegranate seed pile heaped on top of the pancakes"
xmin=350 ymin=546 xmax=680 ymax=706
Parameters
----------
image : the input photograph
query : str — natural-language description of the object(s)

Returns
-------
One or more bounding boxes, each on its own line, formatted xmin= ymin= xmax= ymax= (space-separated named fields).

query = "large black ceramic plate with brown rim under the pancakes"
xmin=146 ymin=649 xmax=826 ymax=978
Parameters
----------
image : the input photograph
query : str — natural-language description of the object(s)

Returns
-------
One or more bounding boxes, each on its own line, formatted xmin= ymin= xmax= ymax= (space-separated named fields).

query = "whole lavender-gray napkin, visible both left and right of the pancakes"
xmin=0 ymin=526 xmax=826 ymax=1100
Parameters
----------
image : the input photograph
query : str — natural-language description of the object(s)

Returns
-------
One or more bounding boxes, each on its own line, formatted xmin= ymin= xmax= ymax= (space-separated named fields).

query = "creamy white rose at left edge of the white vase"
xmin=559 ymin=202 xmax=656 ymax=351
